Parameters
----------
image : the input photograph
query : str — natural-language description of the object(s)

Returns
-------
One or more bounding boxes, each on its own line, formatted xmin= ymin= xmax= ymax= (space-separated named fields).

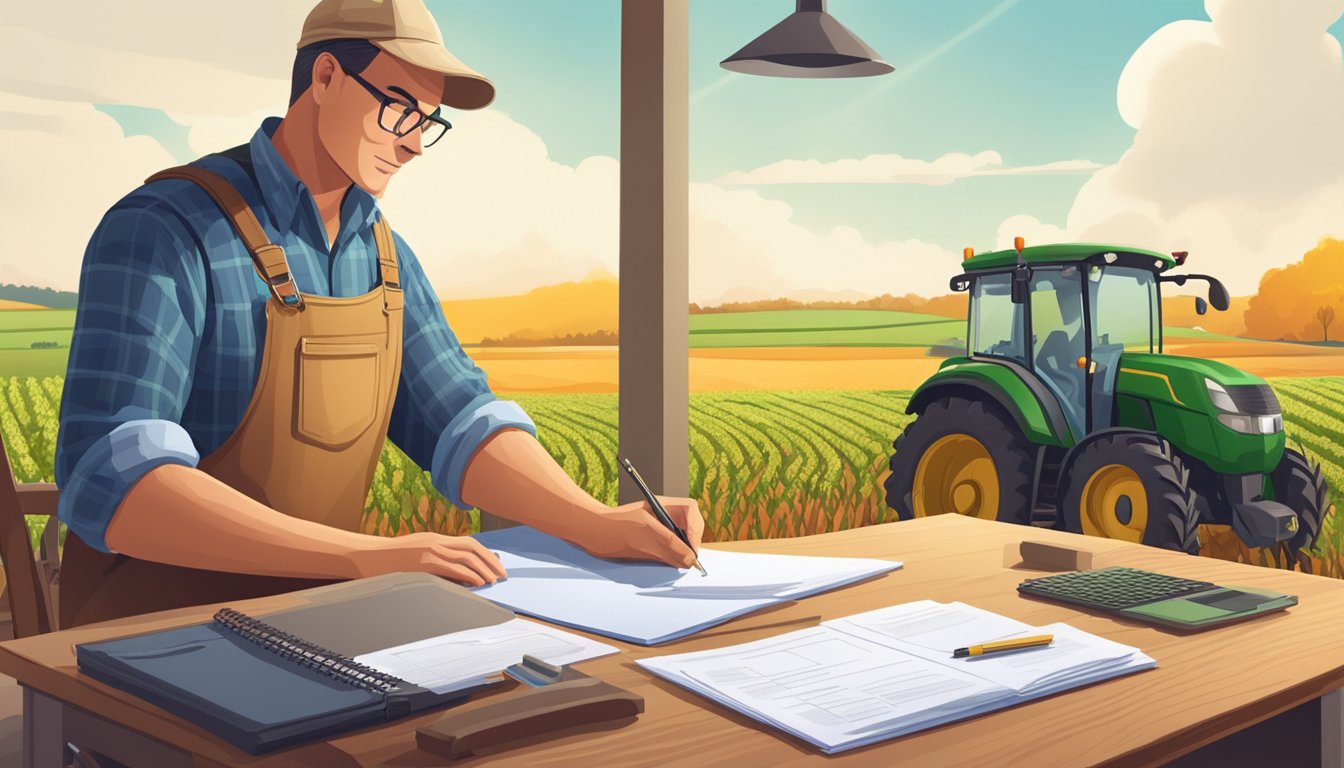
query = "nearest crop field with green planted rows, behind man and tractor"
xmin=0 ymin=377 xmax=1344 ymax=577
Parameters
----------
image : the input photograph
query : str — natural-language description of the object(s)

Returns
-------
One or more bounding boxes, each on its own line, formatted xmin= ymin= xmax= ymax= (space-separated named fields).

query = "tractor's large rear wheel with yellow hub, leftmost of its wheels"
xmin=886 ymin=397 xmax=1036 ymax=523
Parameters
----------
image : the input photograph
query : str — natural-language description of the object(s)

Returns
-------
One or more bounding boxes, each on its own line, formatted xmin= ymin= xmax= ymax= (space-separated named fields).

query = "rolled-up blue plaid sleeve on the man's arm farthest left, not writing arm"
xmin=55 ymin=198 xmax=204 ymax=551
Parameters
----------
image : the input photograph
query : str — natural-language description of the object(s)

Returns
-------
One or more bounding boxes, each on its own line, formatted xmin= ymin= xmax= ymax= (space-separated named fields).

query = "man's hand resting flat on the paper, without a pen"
xmin=349 ymin=533 xmax=508 ymax=586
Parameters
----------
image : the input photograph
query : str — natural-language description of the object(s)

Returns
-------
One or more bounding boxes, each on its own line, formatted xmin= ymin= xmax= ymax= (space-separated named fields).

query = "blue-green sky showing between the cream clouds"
xmin=84 ymin=0 xmax=1344 ymax=297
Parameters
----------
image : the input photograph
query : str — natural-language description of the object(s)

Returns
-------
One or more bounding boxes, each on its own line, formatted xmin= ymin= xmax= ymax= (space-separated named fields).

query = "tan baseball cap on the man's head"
xmin=298 ymin=0 xmax=495 ymax=109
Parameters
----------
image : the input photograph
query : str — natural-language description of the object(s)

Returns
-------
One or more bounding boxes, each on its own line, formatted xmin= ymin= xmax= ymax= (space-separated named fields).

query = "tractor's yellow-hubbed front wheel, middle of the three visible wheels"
xmin=1060 ymin=432 xmax=1199 ymax=554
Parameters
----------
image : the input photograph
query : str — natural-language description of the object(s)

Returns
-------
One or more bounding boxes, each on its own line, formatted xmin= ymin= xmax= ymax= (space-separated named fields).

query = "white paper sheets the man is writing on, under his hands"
xmin=476 ymin=527 xmax=900 ymax=646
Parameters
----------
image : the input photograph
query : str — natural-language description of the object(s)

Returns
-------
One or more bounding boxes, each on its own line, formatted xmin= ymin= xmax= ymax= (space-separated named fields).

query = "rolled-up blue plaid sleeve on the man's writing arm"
xmin=387 ymin=235 xmax=536 ymax=508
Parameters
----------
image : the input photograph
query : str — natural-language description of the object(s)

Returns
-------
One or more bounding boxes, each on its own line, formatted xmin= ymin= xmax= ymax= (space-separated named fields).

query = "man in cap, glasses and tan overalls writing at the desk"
xmin=55 ymin=0 xmax=703 ymax=627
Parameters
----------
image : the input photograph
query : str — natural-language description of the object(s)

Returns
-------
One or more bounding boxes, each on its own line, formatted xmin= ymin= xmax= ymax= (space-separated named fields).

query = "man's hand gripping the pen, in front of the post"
xmin=573 ymin=496 xmax=704 ymax=568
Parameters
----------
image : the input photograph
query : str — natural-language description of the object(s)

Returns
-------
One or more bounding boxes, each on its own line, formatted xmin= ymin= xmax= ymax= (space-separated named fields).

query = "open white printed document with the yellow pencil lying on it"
xmin=637 ymin=600 xmax=1157 ymax=753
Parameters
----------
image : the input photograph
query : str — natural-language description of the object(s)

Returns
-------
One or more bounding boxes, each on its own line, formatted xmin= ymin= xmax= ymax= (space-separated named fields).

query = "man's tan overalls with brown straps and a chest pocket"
xmin=59 ymin=165 xmax=402 ymax=628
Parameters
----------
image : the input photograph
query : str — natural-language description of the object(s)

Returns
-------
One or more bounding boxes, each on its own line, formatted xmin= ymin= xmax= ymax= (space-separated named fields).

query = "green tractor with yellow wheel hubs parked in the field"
xmin=886 ymin=238 xmax=1329 ymax=557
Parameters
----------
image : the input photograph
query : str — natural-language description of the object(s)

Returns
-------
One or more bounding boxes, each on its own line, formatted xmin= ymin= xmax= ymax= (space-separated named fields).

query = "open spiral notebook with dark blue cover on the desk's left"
xmin=75 ymin=573 xmax=540 ymax=755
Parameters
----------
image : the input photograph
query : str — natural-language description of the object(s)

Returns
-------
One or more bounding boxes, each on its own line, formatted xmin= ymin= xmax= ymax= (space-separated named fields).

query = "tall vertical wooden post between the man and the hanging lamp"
xmin=612 ymin=0 xmax=689 ymax=503
